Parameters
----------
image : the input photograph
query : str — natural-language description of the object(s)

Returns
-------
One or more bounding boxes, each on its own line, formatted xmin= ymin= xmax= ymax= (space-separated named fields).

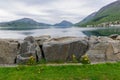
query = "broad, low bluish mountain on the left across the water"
xmin=0 ymin=18 xmax=50 ymax=27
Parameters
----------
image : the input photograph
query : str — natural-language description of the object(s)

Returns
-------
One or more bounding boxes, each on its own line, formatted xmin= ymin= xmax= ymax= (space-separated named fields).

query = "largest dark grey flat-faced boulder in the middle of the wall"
xmin=42 ymin=37 xmax=88 ymax=62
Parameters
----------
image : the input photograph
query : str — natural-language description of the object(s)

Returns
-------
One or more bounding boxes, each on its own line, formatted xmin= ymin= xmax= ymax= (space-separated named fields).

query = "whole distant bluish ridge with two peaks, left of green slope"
xmin=0 ymin=18 xmax=73 ymax=28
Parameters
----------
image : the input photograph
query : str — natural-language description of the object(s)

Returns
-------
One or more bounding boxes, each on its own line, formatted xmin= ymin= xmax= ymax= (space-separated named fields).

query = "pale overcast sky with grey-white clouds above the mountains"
xmin=0 ymin=0 xmax=116 ymax=24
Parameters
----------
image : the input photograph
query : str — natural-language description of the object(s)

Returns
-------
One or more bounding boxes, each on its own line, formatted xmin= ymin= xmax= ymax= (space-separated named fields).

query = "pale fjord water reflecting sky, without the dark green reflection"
xmin=0 ymin=27 xmax=94 ymax=39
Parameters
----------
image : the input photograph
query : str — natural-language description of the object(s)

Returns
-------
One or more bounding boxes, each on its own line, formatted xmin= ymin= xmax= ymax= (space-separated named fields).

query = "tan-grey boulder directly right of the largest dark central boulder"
xmin=86 ymin=42 xmax=109 ymax=62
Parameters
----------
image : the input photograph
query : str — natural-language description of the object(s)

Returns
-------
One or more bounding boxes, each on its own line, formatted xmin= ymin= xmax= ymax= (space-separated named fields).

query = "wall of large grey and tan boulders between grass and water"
xmin=0 ymin=34 xmax=120 ymax=64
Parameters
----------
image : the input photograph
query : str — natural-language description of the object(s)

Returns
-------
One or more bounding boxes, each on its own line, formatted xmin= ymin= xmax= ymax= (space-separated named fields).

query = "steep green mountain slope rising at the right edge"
xmin=76 ymin=0 xmax=120 ymax=26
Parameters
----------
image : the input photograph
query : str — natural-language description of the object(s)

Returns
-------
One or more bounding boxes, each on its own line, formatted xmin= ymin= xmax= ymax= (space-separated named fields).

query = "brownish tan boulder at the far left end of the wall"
xmin=0 ymin=39 xmax=18 ymax=64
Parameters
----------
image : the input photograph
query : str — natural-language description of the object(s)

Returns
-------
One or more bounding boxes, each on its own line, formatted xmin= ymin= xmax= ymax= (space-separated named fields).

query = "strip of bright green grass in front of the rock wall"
xmin=0 ymin=63 xmax=120 ymax=80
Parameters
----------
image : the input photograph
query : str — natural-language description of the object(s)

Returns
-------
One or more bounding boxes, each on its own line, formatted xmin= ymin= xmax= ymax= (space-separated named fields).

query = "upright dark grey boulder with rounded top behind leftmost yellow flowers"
xmin=16 ymin=36 xmax=42 ymax=64
